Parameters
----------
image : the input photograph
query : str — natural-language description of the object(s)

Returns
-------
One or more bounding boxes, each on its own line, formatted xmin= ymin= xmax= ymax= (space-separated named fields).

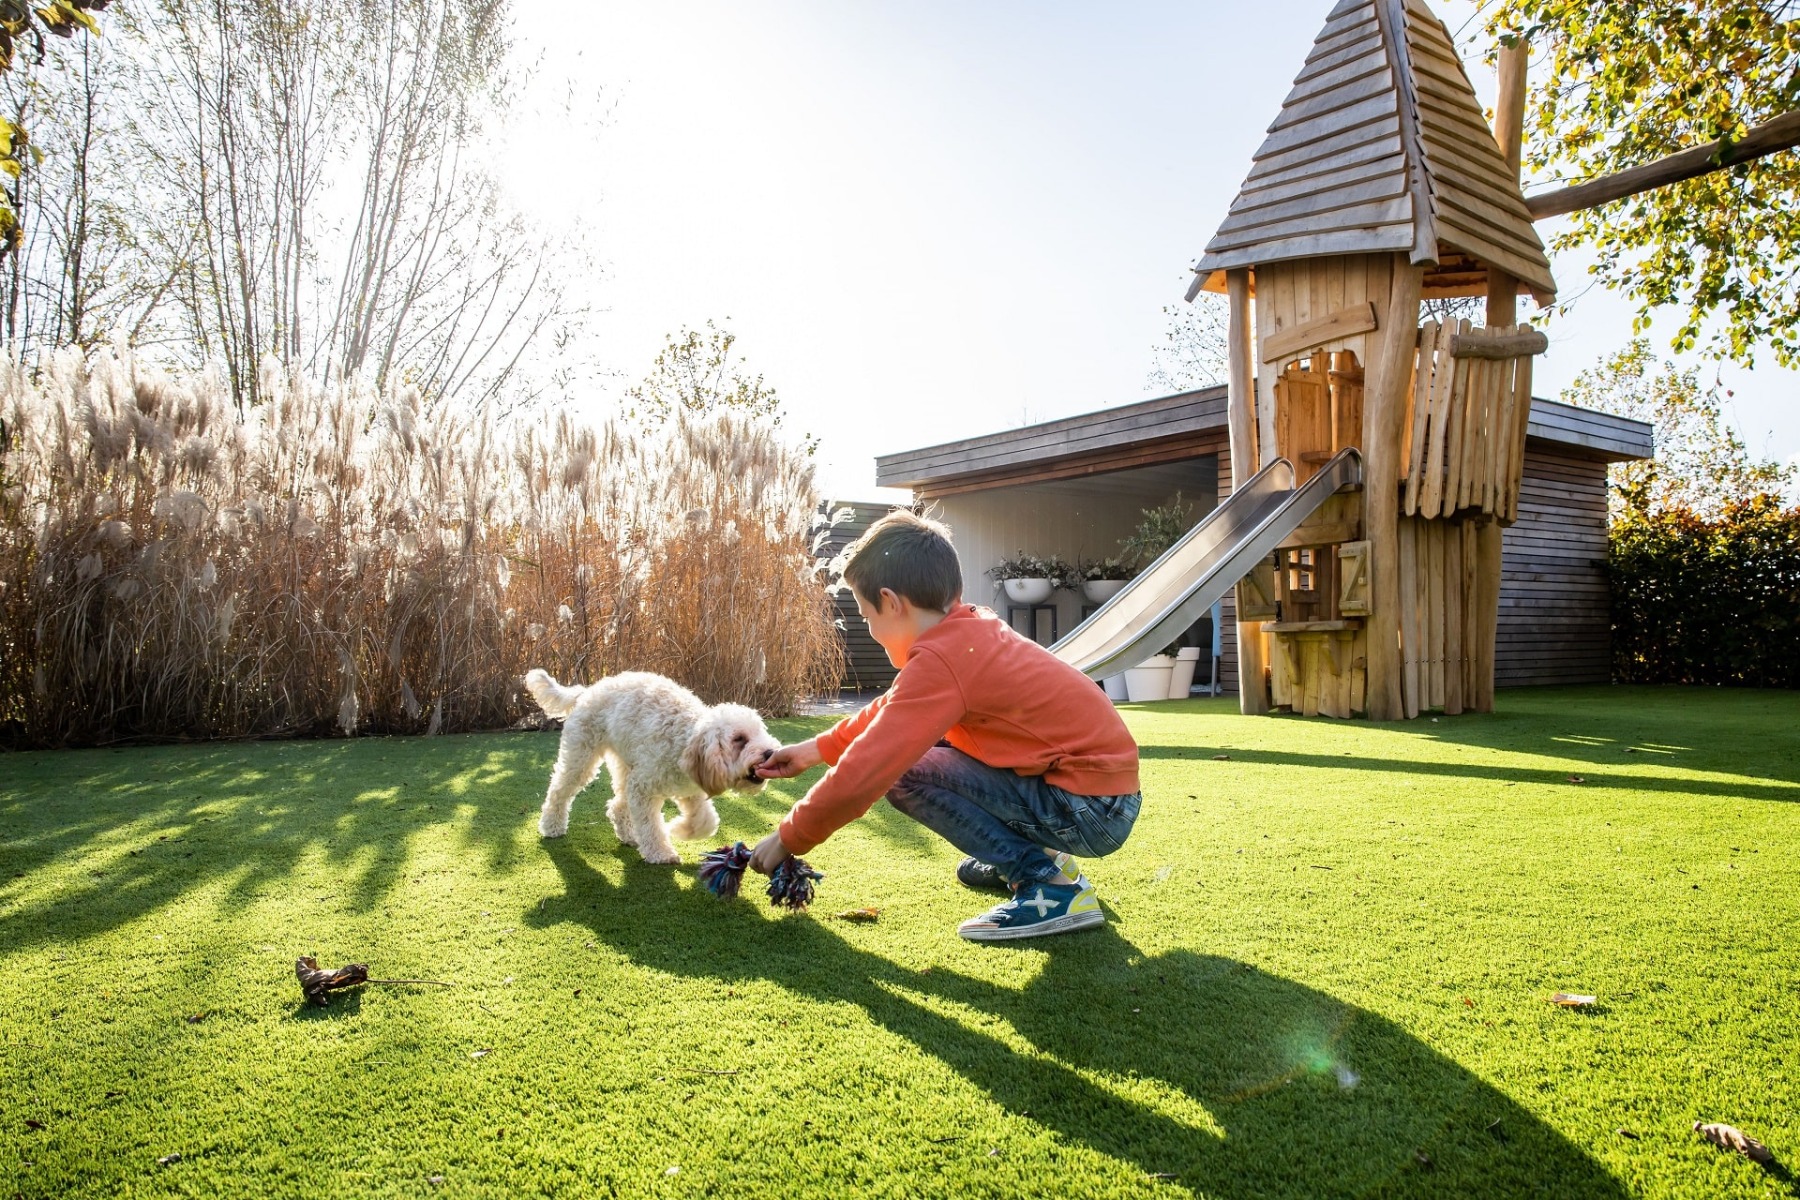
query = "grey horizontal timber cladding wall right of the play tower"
xmin=1494 ymin=441 xmax=1613 ymax=687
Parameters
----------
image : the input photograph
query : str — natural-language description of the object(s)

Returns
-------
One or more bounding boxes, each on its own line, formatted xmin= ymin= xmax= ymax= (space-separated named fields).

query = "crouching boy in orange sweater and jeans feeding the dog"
xmin=751 ymin=511 xmax=1139 ymax=941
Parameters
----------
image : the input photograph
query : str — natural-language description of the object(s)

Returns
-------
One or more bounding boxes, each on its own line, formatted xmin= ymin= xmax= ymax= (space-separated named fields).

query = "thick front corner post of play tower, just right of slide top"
xmin=1363 ymin=254 xmax=1424 ymax=721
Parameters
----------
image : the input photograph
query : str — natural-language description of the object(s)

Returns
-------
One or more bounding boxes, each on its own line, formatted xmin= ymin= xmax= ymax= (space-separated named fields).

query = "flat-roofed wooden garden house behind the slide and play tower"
xmin=864 ymin=387 xmax=1651 ymax=707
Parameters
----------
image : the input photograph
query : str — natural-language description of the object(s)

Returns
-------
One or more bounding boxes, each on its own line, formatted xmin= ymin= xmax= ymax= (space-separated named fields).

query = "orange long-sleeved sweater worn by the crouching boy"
xmin=779 ymin=604 xmax=1138 ymax=855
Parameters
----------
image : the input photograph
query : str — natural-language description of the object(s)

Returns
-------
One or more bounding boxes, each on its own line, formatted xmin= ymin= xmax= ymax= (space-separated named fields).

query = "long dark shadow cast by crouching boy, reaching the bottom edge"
xmin=526 ymin=842 xmax=1627 ymax=1198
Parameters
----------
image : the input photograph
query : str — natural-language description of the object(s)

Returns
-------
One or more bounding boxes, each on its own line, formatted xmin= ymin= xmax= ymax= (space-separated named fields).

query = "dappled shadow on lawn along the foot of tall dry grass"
xmin=0 ymin=721 xmax=922 ymax=948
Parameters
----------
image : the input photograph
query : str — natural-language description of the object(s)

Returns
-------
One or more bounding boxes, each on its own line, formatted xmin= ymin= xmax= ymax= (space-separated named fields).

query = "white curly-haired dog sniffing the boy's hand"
xmin=526 ymin=669 xmax=781 ymax=864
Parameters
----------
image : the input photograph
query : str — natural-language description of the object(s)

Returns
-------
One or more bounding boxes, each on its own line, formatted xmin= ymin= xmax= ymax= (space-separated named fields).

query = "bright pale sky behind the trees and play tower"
xmin=506 ymin=0 xmax=1800 ymax=498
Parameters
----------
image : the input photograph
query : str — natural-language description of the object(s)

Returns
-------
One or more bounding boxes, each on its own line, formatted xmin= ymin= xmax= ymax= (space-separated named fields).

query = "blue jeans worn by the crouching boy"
xmin=887 ymin=747 xmax=1141 ymax=887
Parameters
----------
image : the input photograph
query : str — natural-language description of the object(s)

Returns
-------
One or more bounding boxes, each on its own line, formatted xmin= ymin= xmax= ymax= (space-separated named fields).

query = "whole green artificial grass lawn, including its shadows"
xmin=0 ymin=687 xmax=1800 ymax=1198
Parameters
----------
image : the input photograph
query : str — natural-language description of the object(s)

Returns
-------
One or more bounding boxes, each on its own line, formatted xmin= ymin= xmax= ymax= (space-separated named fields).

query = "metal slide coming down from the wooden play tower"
xmin=1049 ymin=448 xmax=1363 ymax=678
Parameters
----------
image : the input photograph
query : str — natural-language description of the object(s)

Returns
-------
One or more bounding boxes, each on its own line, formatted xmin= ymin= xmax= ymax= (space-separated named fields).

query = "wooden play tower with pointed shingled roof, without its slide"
xmin=1188 ymin=0 xmax=1555 ymax=720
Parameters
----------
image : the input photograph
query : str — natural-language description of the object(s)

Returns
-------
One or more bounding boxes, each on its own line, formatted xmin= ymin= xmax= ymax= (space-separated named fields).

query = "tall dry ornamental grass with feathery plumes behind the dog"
xmin=0 ymin=351 xmax=841 ymax=747
